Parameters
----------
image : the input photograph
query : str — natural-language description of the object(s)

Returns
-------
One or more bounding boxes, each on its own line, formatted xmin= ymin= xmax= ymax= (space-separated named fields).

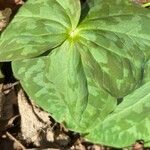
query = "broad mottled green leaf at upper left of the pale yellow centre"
xmin=0 ymin=0 xmax=80 ymax=61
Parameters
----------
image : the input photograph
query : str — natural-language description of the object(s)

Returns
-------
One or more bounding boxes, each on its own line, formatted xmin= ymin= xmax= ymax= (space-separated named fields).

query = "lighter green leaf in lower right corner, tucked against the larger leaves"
xmin=87 ymin=82 xmax=150 ymax=147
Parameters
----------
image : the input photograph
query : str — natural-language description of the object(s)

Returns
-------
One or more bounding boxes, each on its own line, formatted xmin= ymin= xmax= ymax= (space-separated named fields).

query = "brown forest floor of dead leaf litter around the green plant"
xmin=0 ymin=0 xmax=150 ymax=150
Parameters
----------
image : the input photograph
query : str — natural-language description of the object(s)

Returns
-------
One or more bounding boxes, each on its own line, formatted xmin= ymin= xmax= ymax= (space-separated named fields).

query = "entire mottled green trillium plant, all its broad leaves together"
xmin=0 ymin=0 xmax=150 ymax=147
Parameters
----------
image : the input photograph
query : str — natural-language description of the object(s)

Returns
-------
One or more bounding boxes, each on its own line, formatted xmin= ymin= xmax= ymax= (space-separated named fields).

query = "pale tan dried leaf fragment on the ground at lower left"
xmin=18 ymin=90 xmax=54 ymax=147
